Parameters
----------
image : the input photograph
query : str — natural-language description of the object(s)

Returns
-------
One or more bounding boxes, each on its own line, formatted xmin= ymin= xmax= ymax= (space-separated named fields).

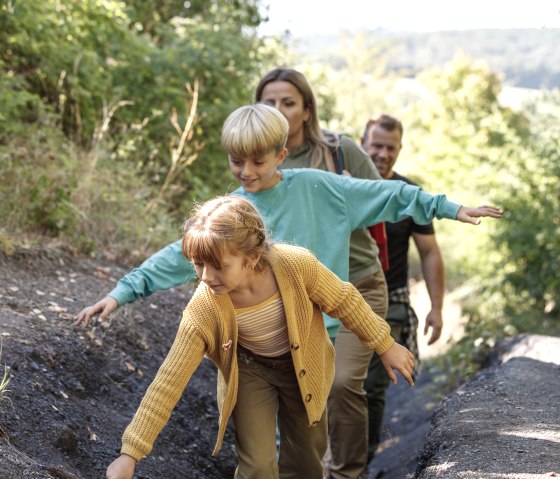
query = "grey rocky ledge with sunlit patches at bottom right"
xmin=416 ymin=335 xmax=560 ymax=479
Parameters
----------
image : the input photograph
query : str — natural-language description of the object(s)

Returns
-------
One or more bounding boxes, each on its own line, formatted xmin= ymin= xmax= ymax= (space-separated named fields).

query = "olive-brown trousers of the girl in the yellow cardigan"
xmin=233 ymin=350 xmax=327 ymax=479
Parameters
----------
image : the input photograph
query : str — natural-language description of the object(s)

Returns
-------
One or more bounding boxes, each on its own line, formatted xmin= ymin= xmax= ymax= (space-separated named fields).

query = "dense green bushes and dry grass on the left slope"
xmin=0 ymin=0 xmax=284 ymax=256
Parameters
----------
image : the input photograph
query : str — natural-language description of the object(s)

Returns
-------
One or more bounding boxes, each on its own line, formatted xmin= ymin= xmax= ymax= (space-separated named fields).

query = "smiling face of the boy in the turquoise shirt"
xmin=228 ymin=148 xmax=288 ymax=193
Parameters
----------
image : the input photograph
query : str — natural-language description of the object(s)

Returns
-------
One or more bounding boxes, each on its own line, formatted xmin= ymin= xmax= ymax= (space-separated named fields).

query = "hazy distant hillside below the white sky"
xmin=293 ymin=29 xmax=560 ymax=89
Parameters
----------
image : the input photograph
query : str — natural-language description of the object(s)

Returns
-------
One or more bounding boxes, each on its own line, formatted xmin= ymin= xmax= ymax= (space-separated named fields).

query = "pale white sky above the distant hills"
xmin=260 ymin=0 xmax=560 ymax=37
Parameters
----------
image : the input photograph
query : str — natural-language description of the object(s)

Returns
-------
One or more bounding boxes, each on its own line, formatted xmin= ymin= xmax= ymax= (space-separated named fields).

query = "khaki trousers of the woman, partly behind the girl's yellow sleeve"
xmin=327 ymin=271 xmax=387 ymax=479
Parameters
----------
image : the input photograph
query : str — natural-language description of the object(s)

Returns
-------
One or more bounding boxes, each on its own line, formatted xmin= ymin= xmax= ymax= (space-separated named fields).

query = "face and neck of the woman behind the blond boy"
xmin=260 ymin=80 xmax=311 ymax=145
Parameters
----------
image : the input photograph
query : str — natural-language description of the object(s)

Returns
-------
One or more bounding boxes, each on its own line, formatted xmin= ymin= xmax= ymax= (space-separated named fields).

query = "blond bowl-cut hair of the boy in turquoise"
xmin=222 ymin=103 xmax=289 ymax=158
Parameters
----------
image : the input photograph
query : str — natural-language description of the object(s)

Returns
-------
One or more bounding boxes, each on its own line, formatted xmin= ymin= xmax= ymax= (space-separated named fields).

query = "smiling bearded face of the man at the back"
xmin=362 ymin=125 xmax=401 ymax=179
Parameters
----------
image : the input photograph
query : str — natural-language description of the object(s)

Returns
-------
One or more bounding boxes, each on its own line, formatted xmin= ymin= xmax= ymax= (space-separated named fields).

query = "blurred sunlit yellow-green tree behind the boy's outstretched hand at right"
xmin=398 ymin=55 xmax=529 ymax=286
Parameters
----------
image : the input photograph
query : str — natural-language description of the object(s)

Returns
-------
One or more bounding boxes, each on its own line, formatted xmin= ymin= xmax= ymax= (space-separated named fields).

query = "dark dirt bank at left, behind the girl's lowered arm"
xmin=0 ymin=250 xmax=235 ymax=479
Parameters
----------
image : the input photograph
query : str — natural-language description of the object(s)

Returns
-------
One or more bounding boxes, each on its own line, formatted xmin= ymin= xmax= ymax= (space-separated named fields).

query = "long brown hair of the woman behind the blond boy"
xmin=255 ymin=68 xmax=329 ymax=168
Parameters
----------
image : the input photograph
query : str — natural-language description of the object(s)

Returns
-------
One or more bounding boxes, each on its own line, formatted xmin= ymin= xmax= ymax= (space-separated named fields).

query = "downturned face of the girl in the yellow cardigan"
xmin=193 ymin=250 xmax=258 ymax=295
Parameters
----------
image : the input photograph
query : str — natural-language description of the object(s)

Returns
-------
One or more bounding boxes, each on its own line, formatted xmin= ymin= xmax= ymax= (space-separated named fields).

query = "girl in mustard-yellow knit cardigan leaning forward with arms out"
xmin=107 ymin=195 xmax=414 ymax=479
